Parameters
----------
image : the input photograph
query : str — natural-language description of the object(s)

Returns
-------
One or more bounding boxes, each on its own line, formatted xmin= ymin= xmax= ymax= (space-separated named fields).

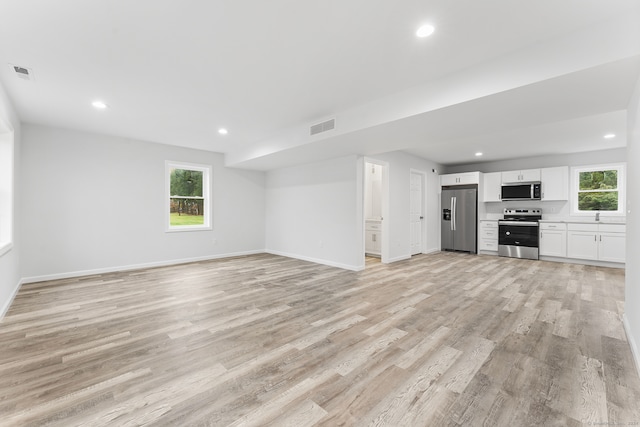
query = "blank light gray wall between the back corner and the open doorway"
xmin=266 ymin=156 xmax=364 ymax=270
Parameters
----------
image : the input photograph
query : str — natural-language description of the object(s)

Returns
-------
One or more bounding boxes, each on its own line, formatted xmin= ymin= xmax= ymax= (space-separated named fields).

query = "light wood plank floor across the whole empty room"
xmin=0 ymin=253 xmax=640 ymax=427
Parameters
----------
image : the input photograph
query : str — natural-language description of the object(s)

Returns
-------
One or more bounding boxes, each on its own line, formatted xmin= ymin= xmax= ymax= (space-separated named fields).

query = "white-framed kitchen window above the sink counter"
xmin=572 ymin=164 xmax=625 ymax=215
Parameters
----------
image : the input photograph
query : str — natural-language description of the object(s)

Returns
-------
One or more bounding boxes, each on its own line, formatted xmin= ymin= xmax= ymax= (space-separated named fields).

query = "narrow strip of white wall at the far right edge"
xmin=624 ymin=75 xmax=640 ymax=373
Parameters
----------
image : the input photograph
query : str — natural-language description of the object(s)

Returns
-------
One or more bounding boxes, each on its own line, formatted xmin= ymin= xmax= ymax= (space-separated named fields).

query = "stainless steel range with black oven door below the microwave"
xmin=498 ymin=209 xmax=542 ymax=259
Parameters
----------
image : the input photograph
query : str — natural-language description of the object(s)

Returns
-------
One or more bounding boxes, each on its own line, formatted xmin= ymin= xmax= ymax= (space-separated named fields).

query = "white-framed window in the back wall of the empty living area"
xmin=165 ymin=161 xmax=211 ymax=231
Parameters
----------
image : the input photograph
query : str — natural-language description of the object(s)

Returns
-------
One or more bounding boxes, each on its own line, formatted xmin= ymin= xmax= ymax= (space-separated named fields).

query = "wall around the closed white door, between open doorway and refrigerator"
xmin=369 ymin=151 xmax=441 ymax=262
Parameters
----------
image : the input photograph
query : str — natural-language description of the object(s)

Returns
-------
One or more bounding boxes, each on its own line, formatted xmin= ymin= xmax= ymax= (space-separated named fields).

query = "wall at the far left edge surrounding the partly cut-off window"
xmin=0 ymin=84 xmax=21 ymax=319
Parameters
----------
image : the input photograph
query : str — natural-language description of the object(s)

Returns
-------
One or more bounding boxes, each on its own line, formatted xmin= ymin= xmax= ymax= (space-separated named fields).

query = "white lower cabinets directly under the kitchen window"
xmin=567 ymin=223 xmax=626 ymax=262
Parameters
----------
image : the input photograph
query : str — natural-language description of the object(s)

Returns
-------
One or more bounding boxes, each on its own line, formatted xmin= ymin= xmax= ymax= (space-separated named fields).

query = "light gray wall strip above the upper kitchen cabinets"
xmin=443 ymin=148 xmax=627 ymax=173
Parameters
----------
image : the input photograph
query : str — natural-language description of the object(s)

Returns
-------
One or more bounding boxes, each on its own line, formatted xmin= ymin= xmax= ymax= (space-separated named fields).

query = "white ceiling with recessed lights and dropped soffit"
xmin=0 ymin=0 xmax=640 ymax=170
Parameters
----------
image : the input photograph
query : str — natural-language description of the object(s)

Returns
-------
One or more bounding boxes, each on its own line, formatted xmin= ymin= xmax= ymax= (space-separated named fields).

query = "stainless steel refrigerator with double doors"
xmin=440 ymin=185 xmax=478 ymax=254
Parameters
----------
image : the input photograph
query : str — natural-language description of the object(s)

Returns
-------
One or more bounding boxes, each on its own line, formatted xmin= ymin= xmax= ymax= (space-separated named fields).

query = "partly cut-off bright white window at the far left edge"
xmin=0 ymin=119 xmax=15 ymax=257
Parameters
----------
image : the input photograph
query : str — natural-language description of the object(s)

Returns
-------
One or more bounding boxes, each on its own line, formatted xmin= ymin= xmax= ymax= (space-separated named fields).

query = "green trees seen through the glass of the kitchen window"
xmin=578 ymin=170 xmax=618 ymax=211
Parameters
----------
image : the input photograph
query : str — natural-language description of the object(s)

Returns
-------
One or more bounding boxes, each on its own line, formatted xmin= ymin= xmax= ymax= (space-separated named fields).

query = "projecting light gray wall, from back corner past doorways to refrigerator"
xmin=267 ymin=151 xmax=440 ymax=270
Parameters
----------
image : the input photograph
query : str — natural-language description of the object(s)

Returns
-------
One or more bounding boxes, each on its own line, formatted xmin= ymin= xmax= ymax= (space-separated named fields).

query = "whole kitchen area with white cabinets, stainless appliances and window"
xmin=440 ymin=164 xmax=626 ymax=268
